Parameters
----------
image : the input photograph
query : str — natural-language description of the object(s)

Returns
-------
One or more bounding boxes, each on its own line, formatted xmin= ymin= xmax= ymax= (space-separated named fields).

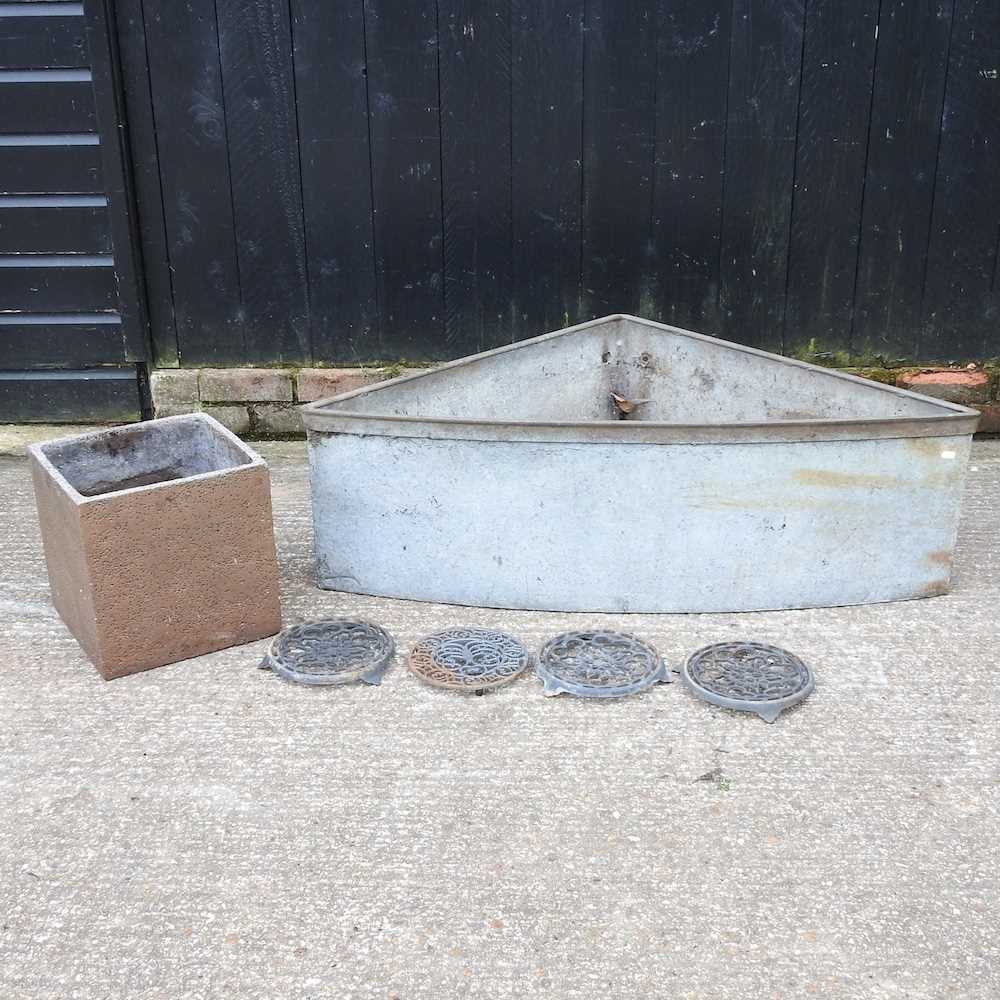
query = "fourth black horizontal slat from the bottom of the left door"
xmin=0 ymin=204 xmax=112 ymax=254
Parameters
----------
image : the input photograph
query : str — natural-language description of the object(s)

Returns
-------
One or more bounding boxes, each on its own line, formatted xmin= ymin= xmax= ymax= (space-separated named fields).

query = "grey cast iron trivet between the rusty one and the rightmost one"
xmin=535 ymin=632 xmax=673 ymax=698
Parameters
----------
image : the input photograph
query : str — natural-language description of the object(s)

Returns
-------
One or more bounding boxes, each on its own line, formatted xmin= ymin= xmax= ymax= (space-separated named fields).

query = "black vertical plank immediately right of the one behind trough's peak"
xmin=653 ymin=0 xmax=732 ymax=333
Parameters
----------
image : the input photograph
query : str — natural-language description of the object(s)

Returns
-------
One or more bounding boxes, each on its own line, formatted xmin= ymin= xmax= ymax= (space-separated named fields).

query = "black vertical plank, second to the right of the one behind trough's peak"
xmin=720 ymin=0 xmax=803 ymax=351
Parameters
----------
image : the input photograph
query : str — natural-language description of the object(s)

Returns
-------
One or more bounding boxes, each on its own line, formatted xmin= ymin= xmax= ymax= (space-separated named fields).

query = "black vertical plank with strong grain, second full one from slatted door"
xmin=217 ymin=0 xmax=310 ymax=362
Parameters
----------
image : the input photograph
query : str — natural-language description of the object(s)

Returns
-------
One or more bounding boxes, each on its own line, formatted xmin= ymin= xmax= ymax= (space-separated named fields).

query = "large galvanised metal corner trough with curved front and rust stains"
xmin=303 ymin=316 xmax=979 ymax=612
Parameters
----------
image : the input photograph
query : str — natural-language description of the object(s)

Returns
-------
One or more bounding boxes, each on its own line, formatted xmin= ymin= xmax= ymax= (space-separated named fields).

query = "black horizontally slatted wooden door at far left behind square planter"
xmin=0 ymin=0 xmax=148 ymax=421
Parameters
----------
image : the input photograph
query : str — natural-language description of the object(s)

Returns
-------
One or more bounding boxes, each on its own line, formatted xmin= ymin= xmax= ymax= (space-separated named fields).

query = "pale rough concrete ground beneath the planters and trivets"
xmin=0 ymin=442 xmax=1000 ymax=1000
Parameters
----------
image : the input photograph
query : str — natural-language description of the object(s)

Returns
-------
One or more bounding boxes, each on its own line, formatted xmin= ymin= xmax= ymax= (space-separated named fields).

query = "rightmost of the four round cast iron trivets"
xmin=683 ymin=642 xmax=813 ymax=722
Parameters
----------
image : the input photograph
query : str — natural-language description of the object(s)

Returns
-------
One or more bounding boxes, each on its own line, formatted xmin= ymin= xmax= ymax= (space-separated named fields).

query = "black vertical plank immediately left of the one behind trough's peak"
xmin=511 ymin=0 xmax=584 ymax=339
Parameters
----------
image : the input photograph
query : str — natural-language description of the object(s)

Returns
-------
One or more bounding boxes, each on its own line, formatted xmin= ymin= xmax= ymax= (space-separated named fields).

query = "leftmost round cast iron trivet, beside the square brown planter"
xmin=261 ymin=618 xmax=396 ymax=684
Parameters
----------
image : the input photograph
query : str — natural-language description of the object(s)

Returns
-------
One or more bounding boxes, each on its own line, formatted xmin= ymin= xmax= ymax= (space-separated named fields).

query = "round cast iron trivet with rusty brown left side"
xmin=410 ymin=626 xmax=531 ymax=692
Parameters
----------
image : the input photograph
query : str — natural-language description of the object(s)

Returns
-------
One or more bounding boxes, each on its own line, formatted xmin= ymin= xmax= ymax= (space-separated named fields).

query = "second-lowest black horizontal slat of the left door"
xmin=0 ymin=314 xmax=127 ymax=369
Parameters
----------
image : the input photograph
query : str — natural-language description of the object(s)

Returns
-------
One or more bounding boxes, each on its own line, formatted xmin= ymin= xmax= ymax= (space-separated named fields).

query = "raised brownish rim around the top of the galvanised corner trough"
xmin=299 ymin=313 xmax=980 ymax=444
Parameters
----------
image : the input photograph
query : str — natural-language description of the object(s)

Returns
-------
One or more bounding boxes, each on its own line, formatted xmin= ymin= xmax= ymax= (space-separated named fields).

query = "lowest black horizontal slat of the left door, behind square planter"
xmin=0 ymin=367 xmax=142 ymax=423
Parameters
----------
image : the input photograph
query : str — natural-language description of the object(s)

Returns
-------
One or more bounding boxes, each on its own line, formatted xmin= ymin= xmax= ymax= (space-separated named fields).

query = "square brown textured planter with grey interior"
xmin=29 ymin=413 xmax=281 ymax=680
